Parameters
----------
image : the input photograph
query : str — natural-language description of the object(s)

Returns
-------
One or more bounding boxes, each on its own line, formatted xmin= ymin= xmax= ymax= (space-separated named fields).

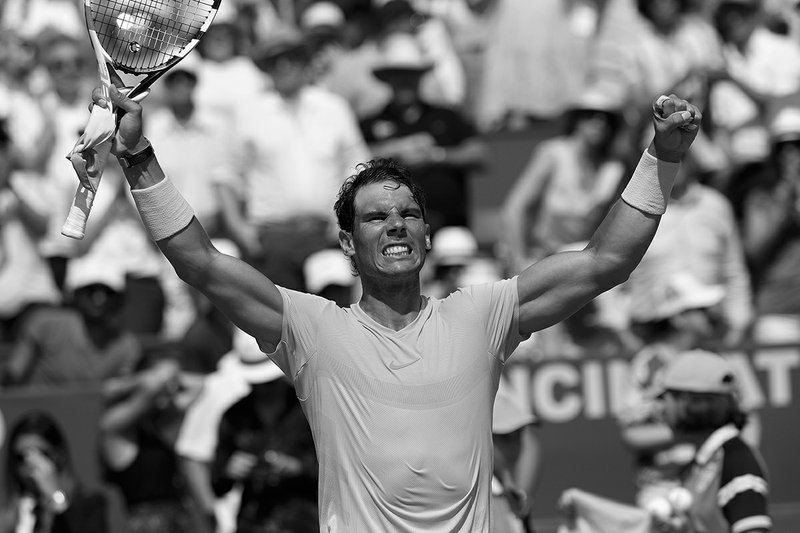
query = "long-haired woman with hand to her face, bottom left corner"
xmin=0 ymin=411 xmax=109 ymax=533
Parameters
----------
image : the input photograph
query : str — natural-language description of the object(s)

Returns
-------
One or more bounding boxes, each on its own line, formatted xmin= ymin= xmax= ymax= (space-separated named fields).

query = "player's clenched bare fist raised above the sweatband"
xmin=648 ymin=94 xmax=703 ymax=163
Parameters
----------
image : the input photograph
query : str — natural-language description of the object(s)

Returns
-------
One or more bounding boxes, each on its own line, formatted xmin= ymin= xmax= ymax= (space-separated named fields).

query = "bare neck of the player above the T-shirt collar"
xmin=358 ymin=277 xmax=422 ymax=331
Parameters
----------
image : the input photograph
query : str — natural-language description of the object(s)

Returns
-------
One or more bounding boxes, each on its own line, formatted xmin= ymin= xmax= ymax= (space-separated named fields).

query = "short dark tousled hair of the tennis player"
xmin=333 ymin=159 xmax=426 ymax=233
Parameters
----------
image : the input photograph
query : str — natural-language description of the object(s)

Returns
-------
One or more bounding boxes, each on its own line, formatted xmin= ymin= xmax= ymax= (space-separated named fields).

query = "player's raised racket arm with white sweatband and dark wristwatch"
xmin=97 ymin=84 xmax=283 ymax=347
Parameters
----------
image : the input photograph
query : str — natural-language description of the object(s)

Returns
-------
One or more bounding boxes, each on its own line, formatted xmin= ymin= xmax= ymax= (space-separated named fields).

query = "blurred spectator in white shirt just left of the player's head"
xmin=220 ymin=26 xmax=368 ymax=289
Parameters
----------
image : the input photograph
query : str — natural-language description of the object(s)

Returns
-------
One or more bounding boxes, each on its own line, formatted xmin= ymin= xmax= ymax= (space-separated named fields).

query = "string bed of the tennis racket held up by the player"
xmin=91 ymin=0 xmax=214 ymax=72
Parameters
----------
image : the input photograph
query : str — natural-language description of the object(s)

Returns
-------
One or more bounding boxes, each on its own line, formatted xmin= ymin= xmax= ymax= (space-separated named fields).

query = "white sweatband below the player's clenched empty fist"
xmin=622 ymin=150 xmax=681 ymax=215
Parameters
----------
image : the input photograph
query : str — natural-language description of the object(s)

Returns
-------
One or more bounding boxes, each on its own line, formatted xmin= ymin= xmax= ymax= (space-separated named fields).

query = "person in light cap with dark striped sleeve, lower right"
xmin=662 ymin=350 xmax=772 ymax=533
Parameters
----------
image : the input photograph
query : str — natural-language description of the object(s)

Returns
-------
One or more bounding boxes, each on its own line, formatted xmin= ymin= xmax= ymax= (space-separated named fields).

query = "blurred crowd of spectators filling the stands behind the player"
xmin=0 ymin=0 xmax=800 ymax=532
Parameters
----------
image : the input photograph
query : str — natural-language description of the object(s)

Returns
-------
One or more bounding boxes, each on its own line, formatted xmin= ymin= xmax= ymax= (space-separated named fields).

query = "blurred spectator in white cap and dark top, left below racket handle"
xmin=3 ymin=255 xmax=142 ymax=386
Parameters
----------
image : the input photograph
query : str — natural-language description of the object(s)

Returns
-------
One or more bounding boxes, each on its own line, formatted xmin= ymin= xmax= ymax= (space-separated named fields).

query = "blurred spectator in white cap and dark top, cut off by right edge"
xmin=741 ymin=102 xmax=800 ymax=344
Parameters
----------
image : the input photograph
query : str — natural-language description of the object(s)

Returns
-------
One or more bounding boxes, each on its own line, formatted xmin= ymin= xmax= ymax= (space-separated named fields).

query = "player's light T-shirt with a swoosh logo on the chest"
xmin=262 ymin=278 xmax=522 ymax=533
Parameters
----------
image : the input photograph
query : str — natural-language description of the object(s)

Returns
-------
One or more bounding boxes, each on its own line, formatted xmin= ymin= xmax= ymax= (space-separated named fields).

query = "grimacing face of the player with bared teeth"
xmin=340 ymin=181 xmax=430 ymax=279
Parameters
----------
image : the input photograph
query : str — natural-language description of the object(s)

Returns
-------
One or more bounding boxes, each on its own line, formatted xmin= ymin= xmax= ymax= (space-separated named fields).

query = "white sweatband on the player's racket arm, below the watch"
xmin=131 ymin=178 xmax=194 ymax=241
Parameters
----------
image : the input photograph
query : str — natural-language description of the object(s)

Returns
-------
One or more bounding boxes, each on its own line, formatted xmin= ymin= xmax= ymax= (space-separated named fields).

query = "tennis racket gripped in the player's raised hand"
xmin=61 ymin=0 xmax=221 ymax=239
